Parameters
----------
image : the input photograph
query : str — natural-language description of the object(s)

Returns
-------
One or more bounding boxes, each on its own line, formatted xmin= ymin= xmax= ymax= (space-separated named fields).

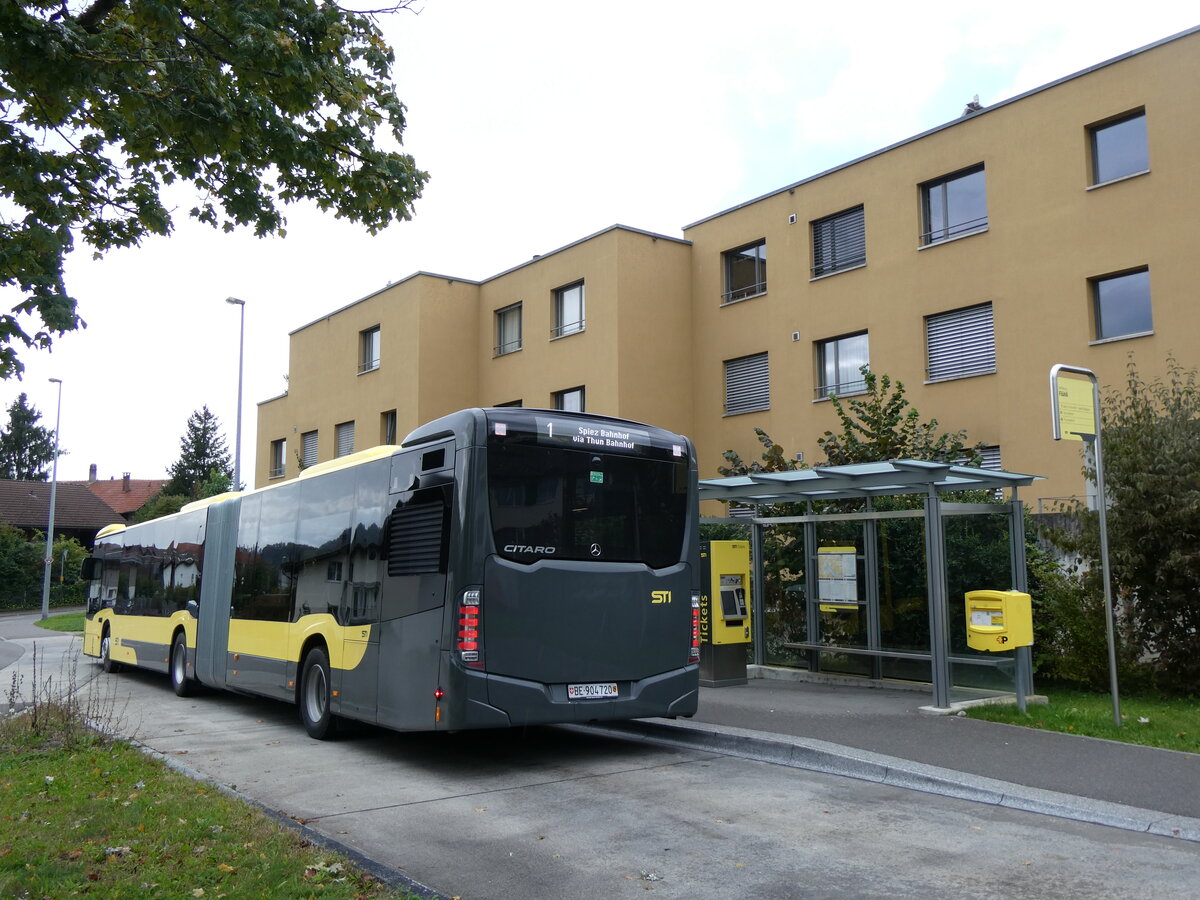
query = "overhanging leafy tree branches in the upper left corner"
xmin=0 ymin=0 xmax=428 ymax=378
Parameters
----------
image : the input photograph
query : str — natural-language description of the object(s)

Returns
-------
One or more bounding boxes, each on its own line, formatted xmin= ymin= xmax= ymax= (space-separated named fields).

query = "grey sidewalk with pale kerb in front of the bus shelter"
xmin=596 ymin=678 xmax=1200 ymax=841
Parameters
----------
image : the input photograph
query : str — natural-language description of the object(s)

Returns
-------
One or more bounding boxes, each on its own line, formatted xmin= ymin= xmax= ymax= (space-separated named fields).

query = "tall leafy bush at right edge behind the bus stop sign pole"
xmin=1056 ymin=358 xmax=1200 ymax=692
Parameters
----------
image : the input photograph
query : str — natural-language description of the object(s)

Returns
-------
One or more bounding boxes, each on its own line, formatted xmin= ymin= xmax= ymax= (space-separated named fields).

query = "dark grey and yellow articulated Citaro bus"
xmin=84 ymin=408 xmax=700 ymax=738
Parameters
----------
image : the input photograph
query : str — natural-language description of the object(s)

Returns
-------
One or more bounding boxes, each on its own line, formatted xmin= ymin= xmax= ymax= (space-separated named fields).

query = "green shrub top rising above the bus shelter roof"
xmin=817 ymin=366 xmax=984 ymax=466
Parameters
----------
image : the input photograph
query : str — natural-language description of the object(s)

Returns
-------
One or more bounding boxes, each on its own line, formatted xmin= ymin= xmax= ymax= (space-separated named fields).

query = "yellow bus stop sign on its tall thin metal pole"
xmin=1050 ymin=364 xmax=1121 ymax=728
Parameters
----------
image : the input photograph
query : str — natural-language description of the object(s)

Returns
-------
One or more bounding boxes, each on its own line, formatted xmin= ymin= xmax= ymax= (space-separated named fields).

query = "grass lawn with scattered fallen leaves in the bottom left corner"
xmin=0 ymin=706 xmax=429 ymax=900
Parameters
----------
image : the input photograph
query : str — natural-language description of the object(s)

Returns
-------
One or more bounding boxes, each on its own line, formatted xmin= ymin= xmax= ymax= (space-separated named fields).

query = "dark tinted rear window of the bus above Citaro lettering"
xmin=487 ymin=444 xmax=688 ymax=569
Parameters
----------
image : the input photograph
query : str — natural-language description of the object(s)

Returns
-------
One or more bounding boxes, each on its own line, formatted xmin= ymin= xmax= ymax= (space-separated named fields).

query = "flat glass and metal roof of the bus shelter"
xmin=700 ymin=460 xmax=1042 ymax=503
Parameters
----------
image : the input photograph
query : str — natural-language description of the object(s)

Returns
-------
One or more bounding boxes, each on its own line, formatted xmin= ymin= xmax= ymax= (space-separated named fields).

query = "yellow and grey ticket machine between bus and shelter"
xmin=700 ymin=541 xmax=752 ymax=688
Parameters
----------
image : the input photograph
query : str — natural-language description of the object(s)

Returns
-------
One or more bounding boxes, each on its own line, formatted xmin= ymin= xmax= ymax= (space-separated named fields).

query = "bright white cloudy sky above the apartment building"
xmin=0 ymin=0 xmax=1198 ymax=482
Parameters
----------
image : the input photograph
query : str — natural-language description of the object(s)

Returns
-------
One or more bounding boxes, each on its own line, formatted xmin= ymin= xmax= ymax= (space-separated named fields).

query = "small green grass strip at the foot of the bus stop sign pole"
xmin=967 ymin=685 xmax=1200 ymax=754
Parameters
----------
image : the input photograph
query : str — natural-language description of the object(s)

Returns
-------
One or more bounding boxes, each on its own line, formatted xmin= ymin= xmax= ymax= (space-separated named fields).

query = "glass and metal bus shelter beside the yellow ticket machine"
xmin=700 ymin=460 xmax=1040 ymax=708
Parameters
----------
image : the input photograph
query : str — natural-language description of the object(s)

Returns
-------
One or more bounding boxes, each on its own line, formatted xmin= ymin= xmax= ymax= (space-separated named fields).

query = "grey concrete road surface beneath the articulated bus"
xmin=2 ymin=619 xmax=1200 ymax=900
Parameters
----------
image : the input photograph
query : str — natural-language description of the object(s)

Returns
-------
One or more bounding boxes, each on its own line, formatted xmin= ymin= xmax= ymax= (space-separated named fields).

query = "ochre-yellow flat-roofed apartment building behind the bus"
xmin=254 ymin=29 xmax=1200 ymax=503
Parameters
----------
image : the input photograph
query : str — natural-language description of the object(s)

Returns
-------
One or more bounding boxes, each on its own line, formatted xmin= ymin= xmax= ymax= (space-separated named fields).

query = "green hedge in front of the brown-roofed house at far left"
xmin=0 ymin=524 xmax=88 ymax=610
